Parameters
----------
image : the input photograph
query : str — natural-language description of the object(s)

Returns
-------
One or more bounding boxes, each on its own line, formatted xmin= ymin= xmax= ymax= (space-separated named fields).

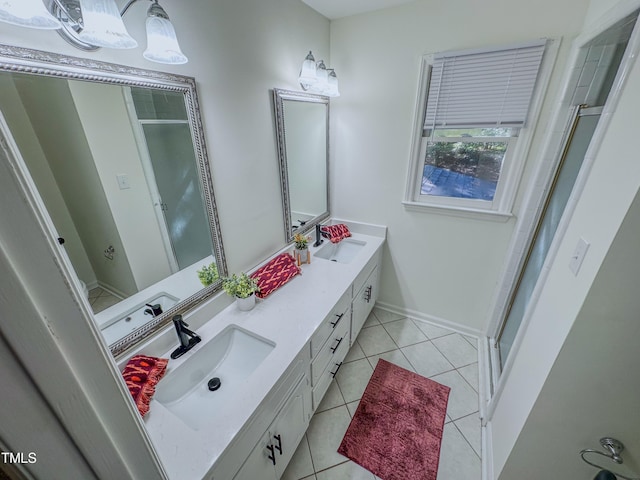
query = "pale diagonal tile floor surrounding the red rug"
xmin=282 ymin=308 xmax=481 ymax=480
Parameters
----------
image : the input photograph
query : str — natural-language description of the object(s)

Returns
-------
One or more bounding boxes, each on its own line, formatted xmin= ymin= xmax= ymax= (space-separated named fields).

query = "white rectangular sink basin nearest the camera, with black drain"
xmin=154 ymin=325 xmax=276 ymax=430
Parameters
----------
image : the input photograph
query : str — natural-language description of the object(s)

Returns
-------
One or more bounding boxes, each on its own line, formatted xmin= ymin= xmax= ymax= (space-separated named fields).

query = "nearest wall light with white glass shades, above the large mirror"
xmin=0 ymin=0 xmax=188 ymax=64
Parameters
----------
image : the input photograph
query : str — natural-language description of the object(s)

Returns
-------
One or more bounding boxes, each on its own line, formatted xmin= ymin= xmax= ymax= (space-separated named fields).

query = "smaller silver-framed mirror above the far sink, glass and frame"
xmin=273 ymin=88 xmax=329 ymax=242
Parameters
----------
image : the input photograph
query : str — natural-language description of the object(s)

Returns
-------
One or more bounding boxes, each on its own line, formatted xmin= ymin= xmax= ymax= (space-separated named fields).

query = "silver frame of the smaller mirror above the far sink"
xmin=273 ymin=88 xmax=331 ymax=243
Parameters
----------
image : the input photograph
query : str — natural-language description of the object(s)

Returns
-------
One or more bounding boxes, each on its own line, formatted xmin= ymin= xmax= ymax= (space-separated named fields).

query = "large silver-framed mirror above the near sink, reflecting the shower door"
xmin=0 ymin=45 xmax=227 ymax=355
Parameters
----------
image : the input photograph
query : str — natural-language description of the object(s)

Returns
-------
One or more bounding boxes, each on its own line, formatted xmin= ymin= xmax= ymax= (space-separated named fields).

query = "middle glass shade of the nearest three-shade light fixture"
xmin=77 ymin=0 xmax=138 ymax=48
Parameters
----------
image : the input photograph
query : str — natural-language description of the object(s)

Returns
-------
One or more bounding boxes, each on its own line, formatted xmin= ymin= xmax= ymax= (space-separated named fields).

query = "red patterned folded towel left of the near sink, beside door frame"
xmin=122 ymin=355 xmax=169 ymax=417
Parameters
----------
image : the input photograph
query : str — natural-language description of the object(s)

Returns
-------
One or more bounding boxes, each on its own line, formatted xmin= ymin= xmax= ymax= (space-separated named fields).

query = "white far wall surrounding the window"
xmin=331 ymin=0 xmax=586 ymax=332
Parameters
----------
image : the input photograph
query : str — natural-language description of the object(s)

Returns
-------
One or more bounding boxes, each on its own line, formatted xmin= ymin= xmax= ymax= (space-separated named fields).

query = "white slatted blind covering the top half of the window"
xmin=424 ymin=40 xmax=546 ymax=131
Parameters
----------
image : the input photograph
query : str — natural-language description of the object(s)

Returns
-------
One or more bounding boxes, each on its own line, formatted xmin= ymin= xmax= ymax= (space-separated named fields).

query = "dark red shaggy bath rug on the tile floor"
xmin=338 ymin=359 xmax=450 ymax=480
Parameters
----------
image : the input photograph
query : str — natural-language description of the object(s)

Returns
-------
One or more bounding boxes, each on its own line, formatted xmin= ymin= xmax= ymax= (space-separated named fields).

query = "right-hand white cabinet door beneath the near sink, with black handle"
xmin=272 ymin=377 xmax=311 ymax=479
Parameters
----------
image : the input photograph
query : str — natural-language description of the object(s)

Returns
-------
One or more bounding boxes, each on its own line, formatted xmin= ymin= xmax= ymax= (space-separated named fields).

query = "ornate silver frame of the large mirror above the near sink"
xmin=0 ymin=45 xmax=228 ymax=356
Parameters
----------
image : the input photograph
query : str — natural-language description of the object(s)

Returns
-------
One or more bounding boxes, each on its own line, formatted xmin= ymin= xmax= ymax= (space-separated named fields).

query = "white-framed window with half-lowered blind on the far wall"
xmin=405 ymin=40 xmax=546 ymax=215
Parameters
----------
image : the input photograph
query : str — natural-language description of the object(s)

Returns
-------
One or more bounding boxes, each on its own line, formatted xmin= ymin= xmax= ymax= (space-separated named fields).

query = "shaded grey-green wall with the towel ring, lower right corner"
xmin=500 ymin=185 xmax=640 ymax=479
